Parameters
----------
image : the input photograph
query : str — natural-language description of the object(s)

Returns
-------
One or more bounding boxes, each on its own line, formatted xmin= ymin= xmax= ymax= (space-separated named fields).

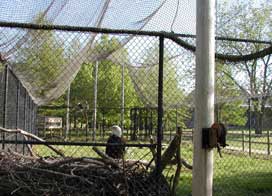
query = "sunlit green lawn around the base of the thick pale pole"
xmin=174 ymin=144 xmax=272 ymax=196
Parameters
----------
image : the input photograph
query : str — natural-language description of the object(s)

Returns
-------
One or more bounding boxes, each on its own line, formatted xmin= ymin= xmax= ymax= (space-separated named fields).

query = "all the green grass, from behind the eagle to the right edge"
xmin=34 ymin=142 xmax=272 ymax=196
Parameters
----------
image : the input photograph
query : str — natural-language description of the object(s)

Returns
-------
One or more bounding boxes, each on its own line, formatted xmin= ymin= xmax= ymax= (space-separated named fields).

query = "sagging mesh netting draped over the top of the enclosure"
xmin=0 ymin=1 xmax=270 ymax=105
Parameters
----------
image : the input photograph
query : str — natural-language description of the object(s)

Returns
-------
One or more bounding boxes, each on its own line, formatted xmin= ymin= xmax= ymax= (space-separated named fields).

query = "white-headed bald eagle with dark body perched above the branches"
xmin=106 ymin=125 xmax=125 ymax=159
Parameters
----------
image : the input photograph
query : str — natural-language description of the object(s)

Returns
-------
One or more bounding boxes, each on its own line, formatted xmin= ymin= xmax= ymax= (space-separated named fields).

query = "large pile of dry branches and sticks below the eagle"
xmin=0 ymin=150 xmax=169 ymax=196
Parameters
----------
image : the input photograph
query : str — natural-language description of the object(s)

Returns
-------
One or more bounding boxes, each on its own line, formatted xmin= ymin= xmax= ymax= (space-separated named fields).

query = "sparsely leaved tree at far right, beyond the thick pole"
xmin=218 ymin=1 xmax=272 ymax=133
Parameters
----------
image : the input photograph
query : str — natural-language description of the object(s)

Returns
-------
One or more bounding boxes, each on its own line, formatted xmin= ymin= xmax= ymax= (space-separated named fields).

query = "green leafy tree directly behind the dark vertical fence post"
xmin=131 ymin=46 xmax=187 ymax=127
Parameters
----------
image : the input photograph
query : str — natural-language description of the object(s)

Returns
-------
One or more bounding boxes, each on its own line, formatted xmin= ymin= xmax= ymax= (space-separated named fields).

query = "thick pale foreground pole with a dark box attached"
xmin=192 ymin=0 xmax=215 ymax=196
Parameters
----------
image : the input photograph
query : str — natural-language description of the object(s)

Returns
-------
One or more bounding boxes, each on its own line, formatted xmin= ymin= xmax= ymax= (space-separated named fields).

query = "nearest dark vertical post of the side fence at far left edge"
xmin=2 ymin=64 xmax=9 ymax=150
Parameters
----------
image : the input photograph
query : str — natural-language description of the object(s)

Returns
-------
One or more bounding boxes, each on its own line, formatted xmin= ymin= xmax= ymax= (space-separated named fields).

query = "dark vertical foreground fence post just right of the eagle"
xmin=156 ymin=35 xmax=164 ymax=174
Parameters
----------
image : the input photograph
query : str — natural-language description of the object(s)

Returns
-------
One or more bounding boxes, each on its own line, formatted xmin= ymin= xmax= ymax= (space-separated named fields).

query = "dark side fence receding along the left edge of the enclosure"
xmin=0 ymin=62 xmax=37 ymax=153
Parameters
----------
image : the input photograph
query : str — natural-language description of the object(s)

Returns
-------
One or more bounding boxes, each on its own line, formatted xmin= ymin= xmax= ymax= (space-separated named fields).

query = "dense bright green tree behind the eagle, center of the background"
xmin=71 ymin=35 xmax=139 ymax=125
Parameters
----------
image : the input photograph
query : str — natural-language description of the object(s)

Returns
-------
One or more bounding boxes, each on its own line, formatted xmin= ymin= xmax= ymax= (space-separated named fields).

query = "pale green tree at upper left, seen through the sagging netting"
xmin=15 ymin=14 xmax=66 ymax=101
